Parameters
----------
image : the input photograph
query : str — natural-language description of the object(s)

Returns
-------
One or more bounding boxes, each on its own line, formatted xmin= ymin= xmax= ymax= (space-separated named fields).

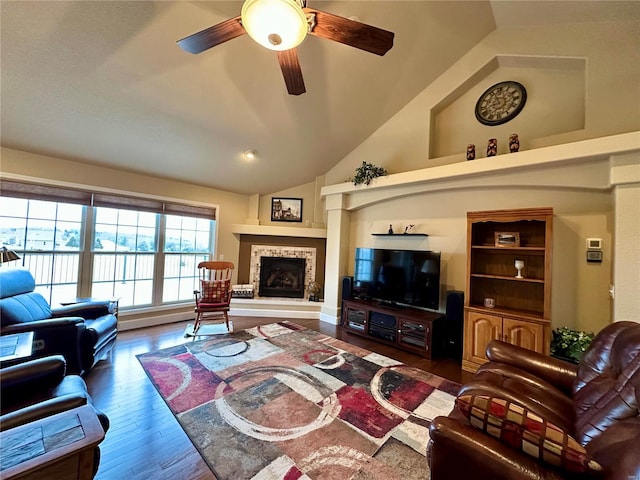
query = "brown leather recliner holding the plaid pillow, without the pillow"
xmin=427 ymin=322 xmax=640 ymax=480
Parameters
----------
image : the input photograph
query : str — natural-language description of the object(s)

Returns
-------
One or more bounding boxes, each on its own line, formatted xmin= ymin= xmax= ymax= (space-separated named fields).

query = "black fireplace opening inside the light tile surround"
xmin=258 ymin=257 xmax=306 ymax=298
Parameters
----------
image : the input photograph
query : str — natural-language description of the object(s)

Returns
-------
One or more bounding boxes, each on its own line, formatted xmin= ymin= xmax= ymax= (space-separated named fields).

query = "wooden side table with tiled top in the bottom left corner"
xmin=0 ymin=405 xmax=104 ymax=480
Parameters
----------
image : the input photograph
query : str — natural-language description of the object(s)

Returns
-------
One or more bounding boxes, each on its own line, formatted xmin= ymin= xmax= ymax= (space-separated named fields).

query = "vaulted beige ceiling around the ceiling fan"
xmin=0 ymin=0 xmax=637 ymax=194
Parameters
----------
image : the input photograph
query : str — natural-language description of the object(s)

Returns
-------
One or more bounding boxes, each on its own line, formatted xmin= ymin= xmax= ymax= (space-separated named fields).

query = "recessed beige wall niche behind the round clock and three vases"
xmin=429 ymin=59 xmax=587 ymax=161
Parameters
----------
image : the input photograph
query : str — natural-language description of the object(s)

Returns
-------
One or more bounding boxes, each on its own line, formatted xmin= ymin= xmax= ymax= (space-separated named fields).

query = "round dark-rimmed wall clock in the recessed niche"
xmin=476 ymin=81 xmax=527 ymax=126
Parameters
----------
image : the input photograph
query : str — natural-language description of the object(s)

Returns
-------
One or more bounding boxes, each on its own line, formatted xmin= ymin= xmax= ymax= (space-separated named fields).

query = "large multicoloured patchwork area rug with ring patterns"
xmin=138 ymin=321 xmax=459 ymax=480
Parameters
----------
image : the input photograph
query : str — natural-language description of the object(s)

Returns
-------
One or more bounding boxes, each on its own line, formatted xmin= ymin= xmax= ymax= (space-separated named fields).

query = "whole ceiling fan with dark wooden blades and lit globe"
xmin=178 ymin=0 xmax=394 ymax=95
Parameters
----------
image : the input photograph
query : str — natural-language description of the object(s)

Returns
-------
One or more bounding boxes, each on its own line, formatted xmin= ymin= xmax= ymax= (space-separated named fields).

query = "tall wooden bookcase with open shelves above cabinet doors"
xmin=462 ymin=208 xmax=553 ymax=372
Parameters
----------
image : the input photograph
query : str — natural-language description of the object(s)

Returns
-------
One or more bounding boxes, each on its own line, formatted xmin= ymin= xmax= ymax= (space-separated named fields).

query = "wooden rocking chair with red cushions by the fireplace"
xmin=193 ymin=261 xmax=234 ymax=334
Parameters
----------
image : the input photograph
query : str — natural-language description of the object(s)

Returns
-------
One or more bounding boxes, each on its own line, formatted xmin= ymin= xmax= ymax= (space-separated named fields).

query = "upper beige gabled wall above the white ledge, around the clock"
xmin=325 ymin=17 xmax=640 ymax=185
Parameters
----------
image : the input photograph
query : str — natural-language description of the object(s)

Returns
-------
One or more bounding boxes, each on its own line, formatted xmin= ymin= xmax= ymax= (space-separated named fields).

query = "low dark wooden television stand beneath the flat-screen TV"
xmin=341 ymin=300 xmax=445 ymax=359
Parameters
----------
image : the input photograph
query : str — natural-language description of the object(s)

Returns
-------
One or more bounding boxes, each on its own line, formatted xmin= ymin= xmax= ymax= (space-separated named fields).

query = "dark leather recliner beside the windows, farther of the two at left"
xmin=0 ymin=268 xmax=118 ymax=374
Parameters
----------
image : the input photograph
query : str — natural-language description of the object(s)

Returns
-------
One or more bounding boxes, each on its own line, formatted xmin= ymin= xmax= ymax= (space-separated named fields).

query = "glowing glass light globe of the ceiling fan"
xmin=241 ymin=0 xmax=308 ymax=50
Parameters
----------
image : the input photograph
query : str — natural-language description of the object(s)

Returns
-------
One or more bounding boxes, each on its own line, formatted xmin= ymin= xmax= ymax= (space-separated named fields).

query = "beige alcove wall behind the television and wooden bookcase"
xmin=347 ymin=187 xmax=613 ymax=331
